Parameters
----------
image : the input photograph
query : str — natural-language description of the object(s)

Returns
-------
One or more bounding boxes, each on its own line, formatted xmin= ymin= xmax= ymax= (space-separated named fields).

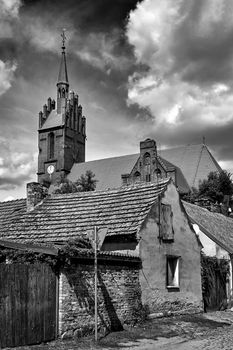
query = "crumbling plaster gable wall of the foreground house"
xmin=139 ymin=183 xmax=202 ymax=313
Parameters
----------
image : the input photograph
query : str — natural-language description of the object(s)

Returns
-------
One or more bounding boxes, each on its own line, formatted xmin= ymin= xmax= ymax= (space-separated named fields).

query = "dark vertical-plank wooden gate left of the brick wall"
xmin=0 ymin=264 xmax=57 ymax=348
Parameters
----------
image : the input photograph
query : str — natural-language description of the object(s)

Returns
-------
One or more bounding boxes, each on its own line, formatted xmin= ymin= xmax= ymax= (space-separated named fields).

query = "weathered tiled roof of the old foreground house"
xmin=0 ymin=180 xmax=170 ymax=243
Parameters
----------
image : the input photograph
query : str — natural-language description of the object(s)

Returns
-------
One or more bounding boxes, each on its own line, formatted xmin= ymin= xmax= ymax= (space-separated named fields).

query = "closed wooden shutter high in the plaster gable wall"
xmin=159 ymin=203 xmax=174 ymax=242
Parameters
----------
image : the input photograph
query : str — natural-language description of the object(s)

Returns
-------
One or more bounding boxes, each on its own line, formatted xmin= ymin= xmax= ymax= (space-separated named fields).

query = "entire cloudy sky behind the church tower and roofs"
xmin=0 ymin=0 xmax=233 ymax=200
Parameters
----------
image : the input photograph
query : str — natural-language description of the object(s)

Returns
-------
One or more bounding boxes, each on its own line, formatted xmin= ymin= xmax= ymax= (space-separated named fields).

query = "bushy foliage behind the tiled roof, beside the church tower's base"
xmin=52 ymin=170 xmax=98 ymax=194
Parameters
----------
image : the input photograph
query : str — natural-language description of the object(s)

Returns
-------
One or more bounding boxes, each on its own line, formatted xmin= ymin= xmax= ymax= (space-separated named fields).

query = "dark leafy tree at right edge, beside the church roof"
xmin=197 ymin=170 xmax=233 ymax=203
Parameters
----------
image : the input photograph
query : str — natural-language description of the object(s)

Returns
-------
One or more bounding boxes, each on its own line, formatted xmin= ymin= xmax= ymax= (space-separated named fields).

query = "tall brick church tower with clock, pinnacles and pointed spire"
xmin=37 ymin=32 xmax=86 ymax=184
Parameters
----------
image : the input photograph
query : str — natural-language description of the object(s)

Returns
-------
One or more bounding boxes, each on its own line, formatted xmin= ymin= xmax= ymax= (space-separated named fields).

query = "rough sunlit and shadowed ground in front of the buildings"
xmin=5 ymin=311 xmax=233 ymax=350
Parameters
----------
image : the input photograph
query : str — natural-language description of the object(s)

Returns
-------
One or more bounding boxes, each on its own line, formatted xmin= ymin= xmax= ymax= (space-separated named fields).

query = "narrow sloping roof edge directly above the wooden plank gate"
xmin=0 ymin=239 xmax=59 ymax=255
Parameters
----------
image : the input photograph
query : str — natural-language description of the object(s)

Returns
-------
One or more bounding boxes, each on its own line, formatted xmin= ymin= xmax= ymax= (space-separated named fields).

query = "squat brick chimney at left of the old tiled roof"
xmin=27 ymin=182 xmax=48 ymax=211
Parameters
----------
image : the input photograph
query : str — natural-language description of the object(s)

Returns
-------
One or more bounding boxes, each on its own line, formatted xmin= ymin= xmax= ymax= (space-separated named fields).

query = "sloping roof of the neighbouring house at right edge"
xmin=182 ymin=201 xmax=233 ymax=254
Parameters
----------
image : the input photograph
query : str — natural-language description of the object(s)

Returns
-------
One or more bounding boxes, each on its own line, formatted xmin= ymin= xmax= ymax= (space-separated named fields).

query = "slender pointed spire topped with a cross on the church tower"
xmin=57 ymin=29 xmax=69 ymax=114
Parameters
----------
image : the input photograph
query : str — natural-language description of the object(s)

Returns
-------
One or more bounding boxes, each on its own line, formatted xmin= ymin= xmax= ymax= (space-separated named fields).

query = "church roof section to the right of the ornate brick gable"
xmin=159 ymin=144 xmax=221 ymax=188
